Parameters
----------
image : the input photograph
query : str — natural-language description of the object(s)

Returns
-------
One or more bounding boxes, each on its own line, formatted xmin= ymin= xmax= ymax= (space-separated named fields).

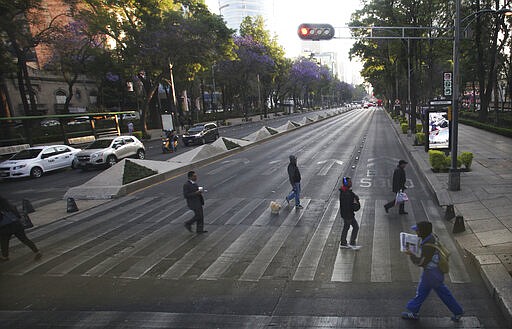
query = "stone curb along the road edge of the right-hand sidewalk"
xmin=386 ymin=111 xmax=512 ymax=328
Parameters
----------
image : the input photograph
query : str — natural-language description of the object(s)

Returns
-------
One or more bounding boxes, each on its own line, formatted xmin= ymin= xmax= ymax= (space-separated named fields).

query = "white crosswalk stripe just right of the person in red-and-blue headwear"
xmin=370 ymin=200 xmax=391 ymax=282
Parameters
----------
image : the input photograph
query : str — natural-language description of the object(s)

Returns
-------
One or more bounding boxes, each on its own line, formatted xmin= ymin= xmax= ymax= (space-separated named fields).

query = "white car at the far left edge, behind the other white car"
xmin=0 ymin=145 xmax=81 ymax=178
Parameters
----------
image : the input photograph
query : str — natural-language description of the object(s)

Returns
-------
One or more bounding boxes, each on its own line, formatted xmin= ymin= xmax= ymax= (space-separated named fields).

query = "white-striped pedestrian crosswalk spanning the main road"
xmin=0 ymin=195 xmax=470 ymax=283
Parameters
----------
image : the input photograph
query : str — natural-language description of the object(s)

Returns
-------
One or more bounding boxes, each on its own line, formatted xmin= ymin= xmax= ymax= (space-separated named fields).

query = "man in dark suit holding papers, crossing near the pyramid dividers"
xmin=183 ymin=171 xmax=208 ymax=234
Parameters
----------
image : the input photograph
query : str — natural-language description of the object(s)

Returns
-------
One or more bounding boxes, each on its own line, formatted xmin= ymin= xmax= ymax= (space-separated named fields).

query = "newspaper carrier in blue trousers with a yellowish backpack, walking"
xmin=402 ymin=221 xmax=464 ymax=322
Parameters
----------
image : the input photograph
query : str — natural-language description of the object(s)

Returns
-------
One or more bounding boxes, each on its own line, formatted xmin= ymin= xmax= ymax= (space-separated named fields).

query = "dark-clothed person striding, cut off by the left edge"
xmin=0 ymin=196 xmax=42 ymax=261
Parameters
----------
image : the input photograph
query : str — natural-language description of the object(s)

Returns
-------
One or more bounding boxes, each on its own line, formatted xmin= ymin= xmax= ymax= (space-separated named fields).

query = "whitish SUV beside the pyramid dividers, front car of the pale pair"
xmin=76 ymin=136 xmax=146 ymax=169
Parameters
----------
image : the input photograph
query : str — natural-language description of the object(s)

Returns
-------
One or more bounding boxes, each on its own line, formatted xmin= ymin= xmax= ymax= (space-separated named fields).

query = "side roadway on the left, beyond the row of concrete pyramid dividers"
xmin=0 ymin=111 xmax=334 ymax=208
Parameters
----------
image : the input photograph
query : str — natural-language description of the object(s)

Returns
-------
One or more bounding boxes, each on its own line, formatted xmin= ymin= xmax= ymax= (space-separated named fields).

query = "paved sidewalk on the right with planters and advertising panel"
xmin=390 ymin=113 xmax=512 ymax=327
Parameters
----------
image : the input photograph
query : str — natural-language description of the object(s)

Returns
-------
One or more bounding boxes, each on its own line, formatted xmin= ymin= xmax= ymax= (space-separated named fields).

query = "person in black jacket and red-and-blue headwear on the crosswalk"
xmin=340 ymin=177 xmax=361 ymax=250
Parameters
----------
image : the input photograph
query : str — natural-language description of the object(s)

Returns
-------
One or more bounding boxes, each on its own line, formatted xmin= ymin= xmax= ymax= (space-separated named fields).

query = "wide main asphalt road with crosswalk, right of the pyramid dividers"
xmin=0 ymin=109 xmax=505 ymax=329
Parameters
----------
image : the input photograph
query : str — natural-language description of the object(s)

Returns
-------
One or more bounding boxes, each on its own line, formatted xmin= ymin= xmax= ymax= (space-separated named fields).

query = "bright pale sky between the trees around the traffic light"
xmin=205 ymin=0 xmax=362 ymax=84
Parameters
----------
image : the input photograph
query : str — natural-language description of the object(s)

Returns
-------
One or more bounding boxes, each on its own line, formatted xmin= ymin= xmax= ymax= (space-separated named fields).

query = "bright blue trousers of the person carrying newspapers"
xmin=407 ymin=268 xmax=464 ymax=315
